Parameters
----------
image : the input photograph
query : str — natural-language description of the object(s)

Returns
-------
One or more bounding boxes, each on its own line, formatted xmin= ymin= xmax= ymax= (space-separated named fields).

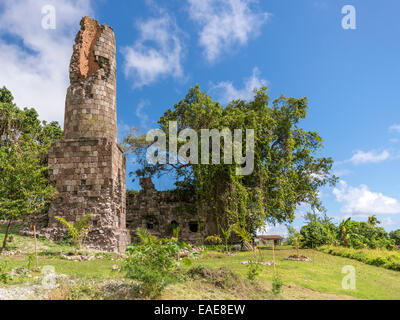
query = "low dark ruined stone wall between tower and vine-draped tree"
xmin=126 ymin=178 xmax=217 ymax=243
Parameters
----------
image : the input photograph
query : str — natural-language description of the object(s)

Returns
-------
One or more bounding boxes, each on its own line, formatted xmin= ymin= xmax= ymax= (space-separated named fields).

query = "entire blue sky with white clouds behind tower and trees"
xmin=0 ymin=0 xmax=400 ymax=233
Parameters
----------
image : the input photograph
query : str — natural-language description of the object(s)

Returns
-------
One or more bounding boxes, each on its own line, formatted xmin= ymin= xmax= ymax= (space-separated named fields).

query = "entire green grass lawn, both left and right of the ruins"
xmin=0 ymin=222 xmax=400 ymax=299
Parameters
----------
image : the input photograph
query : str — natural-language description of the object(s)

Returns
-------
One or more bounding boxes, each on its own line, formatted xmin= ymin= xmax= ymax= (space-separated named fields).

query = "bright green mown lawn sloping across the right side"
xmin=189 ymin=249 xmax=400 ymax=299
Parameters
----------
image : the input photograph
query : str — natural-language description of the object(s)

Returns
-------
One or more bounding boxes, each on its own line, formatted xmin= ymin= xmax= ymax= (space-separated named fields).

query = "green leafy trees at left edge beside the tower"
xmin=0 ymin=87 xmax=62 ymax=251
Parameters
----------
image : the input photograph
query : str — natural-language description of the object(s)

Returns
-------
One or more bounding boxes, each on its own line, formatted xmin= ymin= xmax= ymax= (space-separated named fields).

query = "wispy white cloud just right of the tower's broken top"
xmin=122 ymin=13 xmax=183 ymax=88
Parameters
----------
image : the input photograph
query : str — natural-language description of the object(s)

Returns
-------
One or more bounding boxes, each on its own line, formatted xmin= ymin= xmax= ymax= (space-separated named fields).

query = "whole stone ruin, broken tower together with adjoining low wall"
xmin=23 ymin=17 xmax=217 ymax=252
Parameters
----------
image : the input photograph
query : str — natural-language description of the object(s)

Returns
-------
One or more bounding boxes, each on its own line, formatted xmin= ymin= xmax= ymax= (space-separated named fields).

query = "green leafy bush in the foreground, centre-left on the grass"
xmin=124 ymin=228 xmax=194 ymax=298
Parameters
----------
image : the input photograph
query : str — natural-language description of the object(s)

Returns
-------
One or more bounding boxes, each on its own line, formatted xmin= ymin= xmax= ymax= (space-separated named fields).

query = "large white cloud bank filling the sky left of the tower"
xmin=0 ymin=0 xmax=92 ymax=122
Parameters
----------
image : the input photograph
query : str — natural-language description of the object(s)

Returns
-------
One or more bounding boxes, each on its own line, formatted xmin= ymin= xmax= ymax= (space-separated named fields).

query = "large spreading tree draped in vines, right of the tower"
xmin=125 ymin=86 xmax=336 ymax=239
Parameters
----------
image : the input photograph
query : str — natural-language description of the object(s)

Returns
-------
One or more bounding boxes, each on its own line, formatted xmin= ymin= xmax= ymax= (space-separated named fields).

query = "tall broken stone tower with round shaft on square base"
xmin=48 ymin=17 xmax=129 ymax=252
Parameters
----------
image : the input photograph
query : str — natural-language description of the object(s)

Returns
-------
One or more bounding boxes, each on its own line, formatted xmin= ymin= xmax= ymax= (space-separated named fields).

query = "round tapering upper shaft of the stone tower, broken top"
xmin=64 ymin=17 xmax=117 ymax=141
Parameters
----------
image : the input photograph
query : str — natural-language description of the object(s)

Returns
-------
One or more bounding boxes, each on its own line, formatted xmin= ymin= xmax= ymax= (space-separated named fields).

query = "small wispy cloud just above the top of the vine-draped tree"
xmin=210 ymin=68 xmax=268 ymax=103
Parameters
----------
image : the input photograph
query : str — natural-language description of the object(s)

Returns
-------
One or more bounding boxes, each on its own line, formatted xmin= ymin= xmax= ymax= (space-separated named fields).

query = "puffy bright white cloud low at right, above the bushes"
xmin=333 ymin=180 xmax=400 ymax=216
